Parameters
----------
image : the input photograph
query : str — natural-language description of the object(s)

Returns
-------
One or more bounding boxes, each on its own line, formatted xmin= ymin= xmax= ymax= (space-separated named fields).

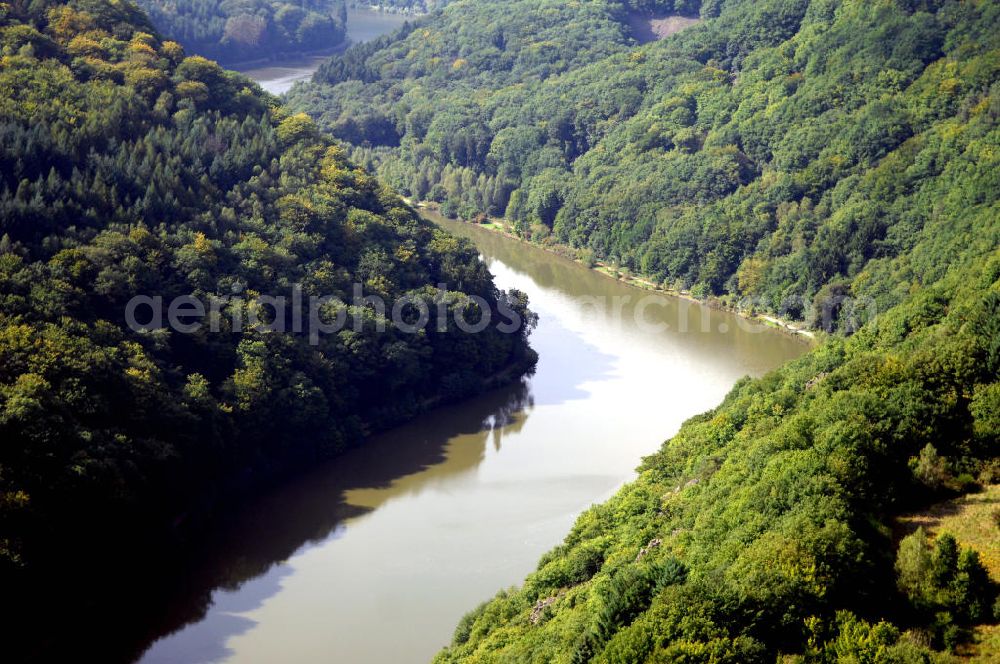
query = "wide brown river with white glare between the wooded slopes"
xmin=135 ymin=213 xmax=806 ymax=664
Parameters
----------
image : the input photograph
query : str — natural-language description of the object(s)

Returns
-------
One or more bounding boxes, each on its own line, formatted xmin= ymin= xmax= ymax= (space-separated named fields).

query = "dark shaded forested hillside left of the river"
xmin=0 ymin=0 xmax=533 ymax=654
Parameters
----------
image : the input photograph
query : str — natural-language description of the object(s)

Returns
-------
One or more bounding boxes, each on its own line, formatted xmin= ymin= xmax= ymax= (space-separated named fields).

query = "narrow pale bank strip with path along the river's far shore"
xmin=403 ymin=197 xmax=820 ymax=344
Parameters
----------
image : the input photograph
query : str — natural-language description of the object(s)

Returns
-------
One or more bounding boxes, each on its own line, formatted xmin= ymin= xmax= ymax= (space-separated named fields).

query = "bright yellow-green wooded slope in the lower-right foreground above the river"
xmin=438 ymin=246 xmax=1000 ymax=662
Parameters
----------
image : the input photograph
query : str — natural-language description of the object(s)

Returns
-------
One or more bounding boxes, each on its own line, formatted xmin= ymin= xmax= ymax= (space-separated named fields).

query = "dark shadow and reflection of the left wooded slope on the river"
xmin=134 ymin=380 xmax=533 ymax=662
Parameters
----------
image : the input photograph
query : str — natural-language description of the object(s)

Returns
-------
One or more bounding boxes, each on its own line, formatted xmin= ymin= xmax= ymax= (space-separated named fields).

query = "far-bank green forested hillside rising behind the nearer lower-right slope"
xmin=292 ymin=0 xmax=1000 ymax=332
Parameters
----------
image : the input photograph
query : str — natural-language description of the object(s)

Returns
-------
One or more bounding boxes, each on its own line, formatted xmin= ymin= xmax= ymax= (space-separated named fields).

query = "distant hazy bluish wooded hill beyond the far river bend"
xmin=136 ymin=0 xmax=347 ymax=63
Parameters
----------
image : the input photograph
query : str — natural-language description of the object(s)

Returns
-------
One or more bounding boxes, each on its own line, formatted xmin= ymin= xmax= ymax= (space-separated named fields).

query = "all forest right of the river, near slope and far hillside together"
xmin=284 ymin=0 xmax=1000 ymax=663
